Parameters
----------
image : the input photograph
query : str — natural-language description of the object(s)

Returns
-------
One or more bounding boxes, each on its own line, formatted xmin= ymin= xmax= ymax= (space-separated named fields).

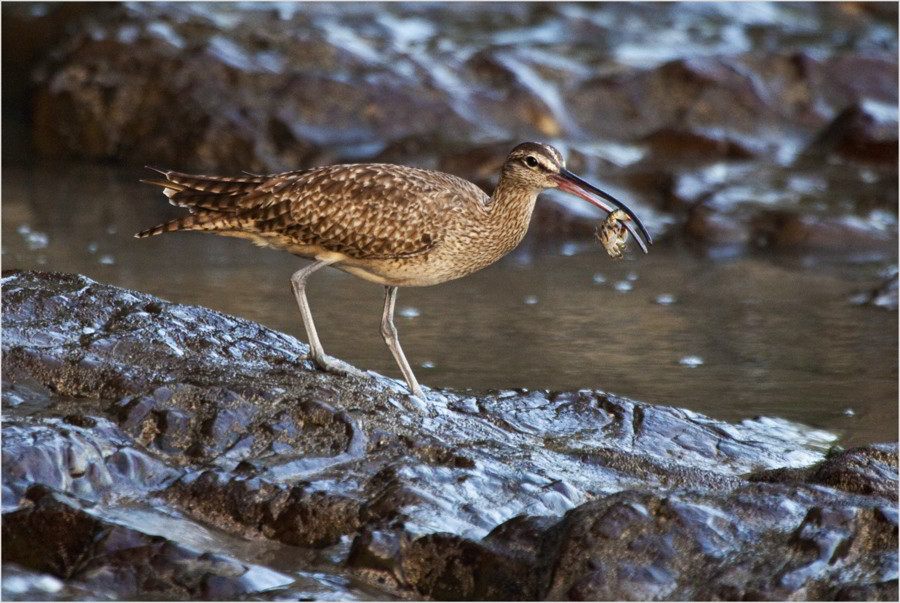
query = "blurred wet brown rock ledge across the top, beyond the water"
xmin=24 ymin=5 xmax=897 ymax=169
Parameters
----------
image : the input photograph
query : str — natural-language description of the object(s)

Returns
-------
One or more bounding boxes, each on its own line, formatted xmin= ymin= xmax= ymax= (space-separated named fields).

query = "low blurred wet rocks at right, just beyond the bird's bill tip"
xmin=671 ymin=160 xmax=896 ymax=261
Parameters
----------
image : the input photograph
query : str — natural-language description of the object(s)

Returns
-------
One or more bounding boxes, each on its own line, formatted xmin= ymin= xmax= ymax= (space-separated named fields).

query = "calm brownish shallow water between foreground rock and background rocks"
xmin=2 ymin=164 xmax=898 ymax=445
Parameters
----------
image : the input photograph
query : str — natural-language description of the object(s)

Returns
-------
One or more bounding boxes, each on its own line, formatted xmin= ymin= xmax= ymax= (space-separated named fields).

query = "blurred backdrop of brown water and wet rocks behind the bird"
xmin=2 ymin=2 xmax=898 ymax=445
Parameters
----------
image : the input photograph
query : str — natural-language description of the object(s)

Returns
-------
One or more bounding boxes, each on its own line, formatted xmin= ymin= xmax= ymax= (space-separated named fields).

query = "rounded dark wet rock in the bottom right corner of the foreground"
xmin=542 ymin=488 xmax=896 ymax=600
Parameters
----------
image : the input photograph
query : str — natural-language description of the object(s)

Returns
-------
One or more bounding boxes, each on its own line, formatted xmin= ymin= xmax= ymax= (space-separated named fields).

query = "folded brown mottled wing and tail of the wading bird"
xmin=145 ymin=164 xmax=487 ymax=259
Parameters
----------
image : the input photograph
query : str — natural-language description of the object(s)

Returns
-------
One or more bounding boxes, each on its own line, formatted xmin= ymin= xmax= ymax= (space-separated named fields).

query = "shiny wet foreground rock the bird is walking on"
xmin=2 ymin=272 xmax=898 ymax=600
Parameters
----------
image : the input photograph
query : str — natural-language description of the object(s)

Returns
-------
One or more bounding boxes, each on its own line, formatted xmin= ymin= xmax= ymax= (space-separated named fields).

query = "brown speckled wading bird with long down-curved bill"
xmin=135 ymin=142 xmax=653 ymax=401
